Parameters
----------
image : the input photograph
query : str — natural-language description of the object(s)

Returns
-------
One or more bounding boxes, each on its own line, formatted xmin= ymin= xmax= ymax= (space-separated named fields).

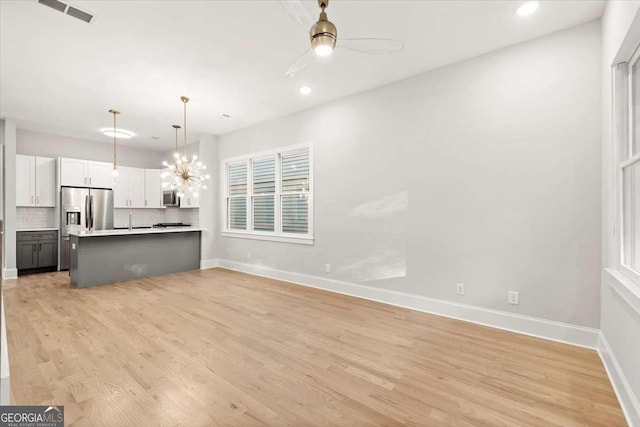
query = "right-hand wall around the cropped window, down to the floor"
xmin=601 ymin=1 xmax=640 ymax=425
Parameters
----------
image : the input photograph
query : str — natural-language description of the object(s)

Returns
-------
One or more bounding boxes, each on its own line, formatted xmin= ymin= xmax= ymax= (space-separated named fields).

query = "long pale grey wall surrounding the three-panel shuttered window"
xmin=219 ymin=22 xmax=601 ymax=327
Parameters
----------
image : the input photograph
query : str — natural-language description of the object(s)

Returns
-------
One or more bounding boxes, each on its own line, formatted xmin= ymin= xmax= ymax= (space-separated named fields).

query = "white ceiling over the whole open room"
xmin=0 ymin=0 xmax=604 ymax=150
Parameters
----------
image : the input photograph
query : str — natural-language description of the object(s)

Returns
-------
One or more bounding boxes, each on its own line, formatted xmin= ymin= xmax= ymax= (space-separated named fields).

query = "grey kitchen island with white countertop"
xmin=69 ymin=227 xmax=202 ymax=288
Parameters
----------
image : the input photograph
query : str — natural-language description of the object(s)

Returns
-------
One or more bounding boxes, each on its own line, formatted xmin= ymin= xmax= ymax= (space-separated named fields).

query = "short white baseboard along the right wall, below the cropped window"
xmin=598 ymin=332 xmax=640 ymax=427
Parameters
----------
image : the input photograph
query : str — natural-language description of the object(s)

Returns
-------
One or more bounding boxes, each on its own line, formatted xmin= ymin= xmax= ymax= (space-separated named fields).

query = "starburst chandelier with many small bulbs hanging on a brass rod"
xmin=162 ymin=96 xmax=210 ymax=197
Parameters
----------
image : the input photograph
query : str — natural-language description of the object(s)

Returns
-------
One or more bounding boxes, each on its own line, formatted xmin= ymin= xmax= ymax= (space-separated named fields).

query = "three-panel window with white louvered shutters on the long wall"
xmin=223 ymin=145 xmax=313 ymax=244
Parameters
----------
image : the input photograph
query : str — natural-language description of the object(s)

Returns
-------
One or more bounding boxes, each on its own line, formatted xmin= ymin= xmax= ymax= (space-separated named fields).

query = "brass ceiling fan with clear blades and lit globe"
xmin=280 ymin=0 xmax=404 ymax=77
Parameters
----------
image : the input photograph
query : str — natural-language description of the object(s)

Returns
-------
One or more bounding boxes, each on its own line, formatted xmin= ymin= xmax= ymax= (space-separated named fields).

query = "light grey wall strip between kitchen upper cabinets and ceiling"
xmin=17 ymin=129 xmax=164 ymax=169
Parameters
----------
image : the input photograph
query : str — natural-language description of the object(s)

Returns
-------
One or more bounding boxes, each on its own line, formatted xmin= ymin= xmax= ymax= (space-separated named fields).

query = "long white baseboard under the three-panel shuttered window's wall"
xmin=216 ymin=259 xmax=600 ymax=349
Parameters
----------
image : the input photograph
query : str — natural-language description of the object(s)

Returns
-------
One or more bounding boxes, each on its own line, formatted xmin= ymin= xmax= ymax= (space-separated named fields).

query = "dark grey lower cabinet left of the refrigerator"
xmin=16 ymin=231 xmax=58 ymax=271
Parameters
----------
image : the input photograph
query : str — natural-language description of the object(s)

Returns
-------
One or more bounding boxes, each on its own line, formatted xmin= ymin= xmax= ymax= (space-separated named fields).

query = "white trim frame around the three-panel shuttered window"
xmin=220 ymin=141 xmax=315 ymax=245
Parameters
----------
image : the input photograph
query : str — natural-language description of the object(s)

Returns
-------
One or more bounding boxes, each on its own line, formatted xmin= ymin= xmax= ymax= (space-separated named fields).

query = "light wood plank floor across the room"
xmin=5 ymin=269 xmax=626 ymax=427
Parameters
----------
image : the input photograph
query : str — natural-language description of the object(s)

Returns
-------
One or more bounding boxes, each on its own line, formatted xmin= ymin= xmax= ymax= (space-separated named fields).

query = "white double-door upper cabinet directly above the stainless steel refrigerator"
xmin=60 ymin=158 xmax=113 ymax=188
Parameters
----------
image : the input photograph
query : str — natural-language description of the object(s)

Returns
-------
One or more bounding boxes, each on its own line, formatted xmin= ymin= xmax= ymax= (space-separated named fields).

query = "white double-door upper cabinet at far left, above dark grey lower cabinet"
xmin=16 ymin=154 xmax=56 ymax=207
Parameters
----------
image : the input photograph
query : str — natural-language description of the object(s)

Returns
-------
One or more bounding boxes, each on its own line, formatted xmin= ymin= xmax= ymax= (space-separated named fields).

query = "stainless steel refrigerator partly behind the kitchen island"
xmin=60 ymin=186 xmax=113 ymax=270
